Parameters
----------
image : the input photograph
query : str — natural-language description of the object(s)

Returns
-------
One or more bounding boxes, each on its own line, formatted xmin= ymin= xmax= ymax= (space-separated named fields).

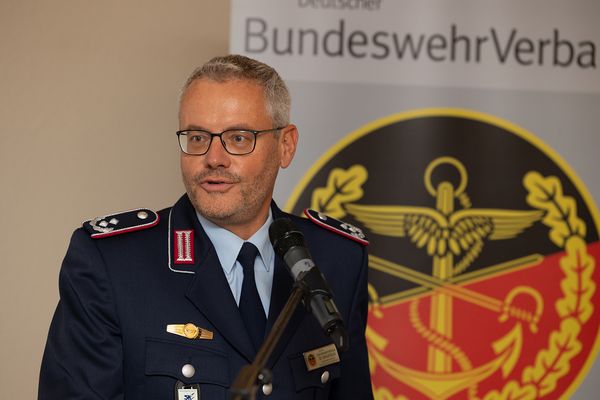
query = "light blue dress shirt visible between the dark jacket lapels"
xmin=196 ymin=210 xmax=275 ymax=316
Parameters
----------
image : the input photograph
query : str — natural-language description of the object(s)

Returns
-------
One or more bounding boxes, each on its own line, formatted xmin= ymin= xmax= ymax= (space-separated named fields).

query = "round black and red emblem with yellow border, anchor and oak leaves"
xmin=286 ymin=109 xmax=600 ymax=400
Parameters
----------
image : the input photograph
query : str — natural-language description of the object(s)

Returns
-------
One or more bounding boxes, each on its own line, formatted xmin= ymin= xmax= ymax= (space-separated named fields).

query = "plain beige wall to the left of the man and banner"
xmin=0 ymin=0 xmax=229 ymax=399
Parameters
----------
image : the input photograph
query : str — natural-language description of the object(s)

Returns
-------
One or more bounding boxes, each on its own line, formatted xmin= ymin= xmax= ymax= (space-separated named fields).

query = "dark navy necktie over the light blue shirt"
xmin=237 ymin=242 xmax=267 ymax=351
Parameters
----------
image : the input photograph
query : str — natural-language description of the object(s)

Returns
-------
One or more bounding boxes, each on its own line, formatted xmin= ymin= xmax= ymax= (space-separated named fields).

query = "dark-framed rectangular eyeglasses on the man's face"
xmin=176 ymin=127 xmax=284 ymax=156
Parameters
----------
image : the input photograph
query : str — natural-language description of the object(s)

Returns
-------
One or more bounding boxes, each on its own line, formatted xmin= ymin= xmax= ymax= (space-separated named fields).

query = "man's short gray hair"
xmin=181 ymin=54 xmax=291 ymax=127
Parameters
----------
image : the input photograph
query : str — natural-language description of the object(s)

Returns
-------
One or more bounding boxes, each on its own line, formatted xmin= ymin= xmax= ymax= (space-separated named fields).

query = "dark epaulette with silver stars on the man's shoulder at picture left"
xmin=83 ymin=208 xmax=160 ymax=239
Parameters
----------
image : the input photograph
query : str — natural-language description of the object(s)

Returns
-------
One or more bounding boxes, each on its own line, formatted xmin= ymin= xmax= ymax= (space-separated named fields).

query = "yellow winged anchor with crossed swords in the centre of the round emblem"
xmin=346 ymin=157 xmax=543 ymax=399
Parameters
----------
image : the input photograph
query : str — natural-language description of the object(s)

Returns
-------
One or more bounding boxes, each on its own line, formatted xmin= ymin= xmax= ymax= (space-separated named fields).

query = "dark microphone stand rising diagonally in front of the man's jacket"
xmin=229 ymin=281 xmax=308 ymax=400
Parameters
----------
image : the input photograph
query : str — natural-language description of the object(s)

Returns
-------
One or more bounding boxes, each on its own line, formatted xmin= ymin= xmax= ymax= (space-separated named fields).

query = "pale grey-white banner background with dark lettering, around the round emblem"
xmin=231 ymin=0 xmax=600 ymax=399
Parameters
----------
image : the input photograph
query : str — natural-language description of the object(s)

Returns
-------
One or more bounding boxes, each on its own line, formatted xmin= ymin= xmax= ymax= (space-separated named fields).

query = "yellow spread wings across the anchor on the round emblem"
xmin=346 ymin=204 xmax=543 ymax=256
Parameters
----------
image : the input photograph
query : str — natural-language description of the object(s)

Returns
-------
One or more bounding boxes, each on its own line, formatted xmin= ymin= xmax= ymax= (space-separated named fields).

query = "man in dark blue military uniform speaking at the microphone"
xmin=39 ymin=55 xmax=372 ymax=400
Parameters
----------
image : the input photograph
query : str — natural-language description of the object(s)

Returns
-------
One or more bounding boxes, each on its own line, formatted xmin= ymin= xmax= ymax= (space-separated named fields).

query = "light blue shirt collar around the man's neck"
xmin=196 ymin=208 xmax=275 ymax=274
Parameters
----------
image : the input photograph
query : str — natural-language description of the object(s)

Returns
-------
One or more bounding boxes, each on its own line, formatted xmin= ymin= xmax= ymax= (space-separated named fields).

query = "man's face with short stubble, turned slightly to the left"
xmin=179 ymin=79 xmax=297 ymax=236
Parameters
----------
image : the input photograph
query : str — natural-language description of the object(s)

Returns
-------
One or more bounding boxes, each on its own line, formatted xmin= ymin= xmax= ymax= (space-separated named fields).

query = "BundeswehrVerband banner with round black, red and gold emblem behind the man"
xmin=231 ymin=0 xmax=600 ymax=399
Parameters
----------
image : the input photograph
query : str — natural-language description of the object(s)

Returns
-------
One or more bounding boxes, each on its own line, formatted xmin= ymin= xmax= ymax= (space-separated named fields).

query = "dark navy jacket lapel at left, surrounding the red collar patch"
xmin=168 ymin=195 xmax=255 ymax=361
